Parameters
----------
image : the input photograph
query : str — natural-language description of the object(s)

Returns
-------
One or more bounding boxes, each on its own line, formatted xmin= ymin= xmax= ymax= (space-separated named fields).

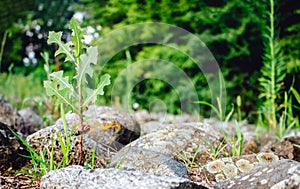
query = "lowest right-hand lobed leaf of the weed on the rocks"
xmin=83 ymin=74 xmax=110 ymax=106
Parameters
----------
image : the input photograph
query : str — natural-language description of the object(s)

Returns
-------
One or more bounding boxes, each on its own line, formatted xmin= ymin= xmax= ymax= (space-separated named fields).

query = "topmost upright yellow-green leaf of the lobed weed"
xmin=70 ymin=18 xmax=86 ymax=57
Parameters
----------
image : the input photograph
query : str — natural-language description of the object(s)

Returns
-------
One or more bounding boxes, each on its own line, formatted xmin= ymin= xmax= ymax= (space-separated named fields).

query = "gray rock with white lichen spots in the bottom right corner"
xmin=215 ymin=159 xmax=300 ymax=189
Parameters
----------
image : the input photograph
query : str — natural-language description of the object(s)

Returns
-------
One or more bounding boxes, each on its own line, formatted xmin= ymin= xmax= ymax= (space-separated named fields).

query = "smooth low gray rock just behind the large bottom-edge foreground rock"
xmin=110 ymin=148 xmax=188 ymax=177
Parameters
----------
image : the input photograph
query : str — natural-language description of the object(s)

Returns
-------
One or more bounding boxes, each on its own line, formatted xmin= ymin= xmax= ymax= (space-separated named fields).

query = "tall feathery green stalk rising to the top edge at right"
xmin=259 ymin=0 xmax=286 ymax=131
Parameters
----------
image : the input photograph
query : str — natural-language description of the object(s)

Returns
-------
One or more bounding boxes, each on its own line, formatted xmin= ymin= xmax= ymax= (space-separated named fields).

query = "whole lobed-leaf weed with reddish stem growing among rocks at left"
xmin=44 ymin=18 xmax=110 ymax=165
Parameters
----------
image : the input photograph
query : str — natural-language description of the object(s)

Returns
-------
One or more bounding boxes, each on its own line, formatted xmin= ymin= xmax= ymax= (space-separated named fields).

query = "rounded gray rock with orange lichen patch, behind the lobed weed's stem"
xmin=57 ymin=106 xmax=140 ymax=151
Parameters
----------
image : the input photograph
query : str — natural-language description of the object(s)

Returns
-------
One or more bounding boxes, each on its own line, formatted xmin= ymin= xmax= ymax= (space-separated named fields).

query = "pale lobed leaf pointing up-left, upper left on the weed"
xmin=47 ymin=31 xmax=75 ymax=62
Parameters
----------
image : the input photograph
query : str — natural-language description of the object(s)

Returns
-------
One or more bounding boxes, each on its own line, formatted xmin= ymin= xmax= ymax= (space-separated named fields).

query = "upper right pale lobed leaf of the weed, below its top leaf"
xmin=75 ymin=47 xmax=98 ymax=84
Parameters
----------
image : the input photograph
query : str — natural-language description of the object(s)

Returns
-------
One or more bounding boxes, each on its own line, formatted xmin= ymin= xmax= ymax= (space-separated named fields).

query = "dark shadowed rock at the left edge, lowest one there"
xmin=0 ymin=122 xmax=29 ymax=173
